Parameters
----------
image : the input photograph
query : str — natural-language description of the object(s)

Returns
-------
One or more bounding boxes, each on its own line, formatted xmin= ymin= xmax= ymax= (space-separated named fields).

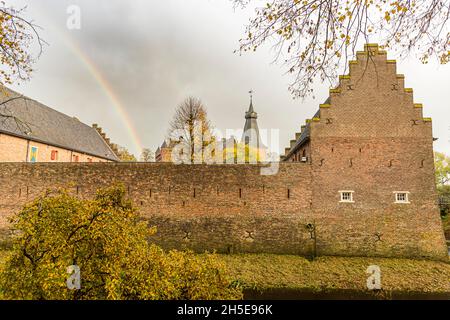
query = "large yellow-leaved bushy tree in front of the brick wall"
xmin=0 ymin=186 xmax=242 ymax=300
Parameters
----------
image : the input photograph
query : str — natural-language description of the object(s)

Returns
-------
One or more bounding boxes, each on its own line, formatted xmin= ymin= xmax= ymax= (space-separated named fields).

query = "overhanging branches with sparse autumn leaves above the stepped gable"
xmin=232 ymin=0 xmax=450 ymax=98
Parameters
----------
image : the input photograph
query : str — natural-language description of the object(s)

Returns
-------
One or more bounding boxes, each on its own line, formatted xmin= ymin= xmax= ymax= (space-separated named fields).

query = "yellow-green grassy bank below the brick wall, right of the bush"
xmin=220 ymin=254 xmax=450 ymax=293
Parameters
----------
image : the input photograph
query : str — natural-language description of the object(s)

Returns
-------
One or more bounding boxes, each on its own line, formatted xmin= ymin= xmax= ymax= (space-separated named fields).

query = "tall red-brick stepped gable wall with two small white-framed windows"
xmin=311 ymin=46 xmax=447 ymax=257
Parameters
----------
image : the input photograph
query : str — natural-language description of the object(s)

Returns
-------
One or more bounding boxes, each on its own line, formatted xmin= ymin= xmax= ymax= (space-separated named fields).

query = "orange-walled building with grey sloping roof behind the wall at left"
xmin=0 ymin=87 xmax=118 ymax=162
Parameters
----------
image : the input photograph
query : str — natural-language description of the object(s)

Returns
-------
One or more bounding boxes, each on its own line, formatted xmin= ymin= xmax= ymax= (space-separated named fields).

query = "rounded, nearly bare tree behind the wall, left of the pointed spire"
xmin=168 ymin=97 xmax=215 ymax=163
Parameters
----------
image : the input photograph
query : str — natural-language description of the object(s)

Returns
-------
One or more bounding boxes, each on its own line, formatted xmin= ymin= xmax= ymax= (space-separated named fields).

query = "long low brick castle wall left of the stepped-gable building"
xmin=0 ymin=163 xmax=311 ymax=254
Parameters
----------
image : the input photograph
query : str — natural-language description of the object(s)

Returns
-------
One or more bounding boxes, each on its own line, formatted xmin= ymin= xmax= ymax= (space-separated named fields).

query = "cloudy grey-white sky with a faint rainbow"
xmin=6 ymin=0 xmax=450 ymax=156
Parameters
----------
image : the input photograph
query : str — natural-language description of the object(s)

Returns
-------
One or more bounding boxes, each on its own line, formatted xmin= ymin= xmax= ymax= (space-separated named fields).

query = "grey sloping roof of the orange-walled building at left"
xmin=0 ymin=87 xmax=119 ymax=161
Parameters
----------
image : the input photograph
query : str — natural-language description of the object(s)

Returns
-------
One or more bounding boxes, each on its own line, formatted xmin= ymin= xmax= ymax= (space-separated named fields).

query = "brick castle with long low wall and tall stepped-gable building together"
xmin=0 ymin=44 xmax=448 ymax=260
